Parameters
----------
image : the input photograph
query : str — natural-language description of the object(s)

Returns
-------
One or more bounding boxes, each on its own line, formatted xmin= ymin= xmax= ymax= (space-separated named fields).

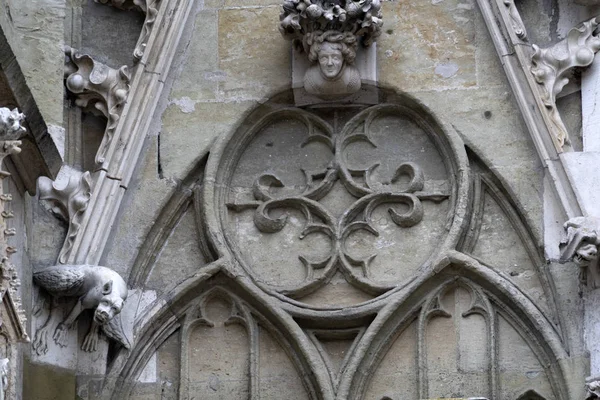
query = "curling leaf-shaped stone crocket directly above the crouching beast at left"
xmin=38 ymin=171 xmax=92 ymax=264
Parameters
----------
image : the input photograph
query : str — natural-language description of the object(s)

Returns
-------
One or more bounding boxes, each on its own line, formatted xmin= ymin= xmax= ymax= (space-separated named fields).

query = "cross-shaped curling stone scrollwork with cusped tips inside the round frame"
xmin=227 ymin=104 xmax=451 ymax=297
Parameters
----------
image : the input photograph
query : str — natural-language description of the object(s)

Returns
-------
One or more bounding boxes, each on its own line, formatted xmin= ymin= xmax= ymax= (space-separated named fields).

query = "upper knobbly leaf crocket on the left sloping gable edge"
xmin=65 ymin=47 xmax=130 ymax=164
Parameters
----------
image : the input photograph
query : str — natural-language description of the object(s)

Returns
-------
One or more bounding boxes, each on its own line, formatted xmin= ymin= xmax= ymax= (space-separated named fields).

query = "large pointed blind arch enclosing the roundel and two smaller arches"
xmin=106 ymin=88 xmax=572 ymax=400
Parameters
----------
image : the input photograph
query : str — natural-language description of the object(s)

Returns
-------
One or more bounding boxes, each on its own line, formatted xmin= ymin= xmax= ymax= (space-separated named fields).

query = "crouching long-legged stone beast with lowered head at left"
xmin=33 ymin=265 xmax=131 ymax=354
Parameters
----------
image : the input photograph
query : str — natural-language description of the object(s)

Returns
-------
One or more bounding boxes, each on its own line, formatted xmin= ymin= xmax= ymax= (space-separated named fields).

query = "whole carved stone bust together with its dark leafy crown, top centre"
xmin=279 ymin=0 xmax=383 ymax=99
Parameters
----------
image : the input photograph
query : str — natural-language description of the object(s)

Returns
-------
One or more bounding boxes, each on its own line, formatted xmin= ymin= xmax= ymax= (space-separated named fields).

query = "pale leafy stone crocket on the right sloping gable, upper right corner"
xmin=531 ymin=17 xmax=600 ymax=147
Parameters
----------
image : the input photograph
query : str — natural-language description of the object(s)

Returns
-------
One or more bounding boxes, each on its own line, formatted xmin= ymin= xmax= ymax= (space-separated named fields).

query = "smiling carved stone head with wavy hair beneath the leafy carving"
xmin=304 ymin=31 xmax=360 ymax=98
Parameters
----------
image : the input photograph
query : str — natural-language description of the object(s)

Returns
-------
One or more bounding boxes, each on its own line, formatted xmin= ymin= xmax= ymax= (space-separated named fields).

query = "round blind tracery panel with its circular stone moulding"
xmin=205 ymin=98 xmax=468 ymax=308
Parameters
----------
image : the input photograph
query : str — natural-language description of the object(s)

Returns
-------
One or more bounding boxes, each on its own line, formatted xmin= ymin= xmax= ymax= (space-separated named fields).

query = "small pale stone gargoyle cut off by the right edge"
xmin=560 ymin=217 xmax=600 ymax=288
